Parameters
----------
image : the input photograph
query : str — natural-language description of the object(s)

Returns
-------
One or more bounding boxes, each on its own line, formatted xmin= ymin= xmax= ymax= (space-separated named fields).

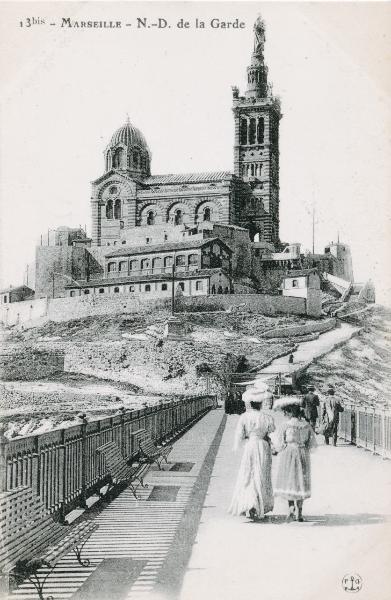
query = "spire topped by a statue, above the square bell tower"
xmin=246 ymin=17 xmax=268 ymax=98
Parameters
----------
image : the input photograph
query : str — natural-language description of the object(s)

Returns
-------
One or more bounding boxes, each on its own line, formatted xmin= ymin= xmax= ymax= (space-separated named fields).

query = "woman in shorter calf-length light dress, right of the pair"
xmin=274 ymin=398 xmax=316 ymax=523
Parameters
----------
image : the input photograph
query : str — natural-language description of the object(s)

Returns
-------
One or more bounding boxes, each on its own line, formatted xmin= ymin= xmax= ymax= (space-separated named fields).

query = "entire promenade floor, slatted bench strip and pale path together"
xmin=6 ymin=409 xmax=391 ymax=600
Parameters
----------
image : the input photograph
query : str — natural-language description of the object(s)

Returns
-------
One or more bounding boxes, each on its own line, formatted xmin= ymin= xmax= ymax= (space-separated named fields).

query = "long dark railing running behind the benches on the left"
xmin=0 ymin=395 xmax=215 ymax=518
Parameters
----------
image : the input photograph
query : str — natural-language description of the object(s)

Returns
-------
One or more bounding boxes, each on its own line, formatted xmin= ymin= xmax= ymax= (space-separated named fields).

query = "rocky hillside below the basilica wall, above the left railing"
xmin=0 ymin=312 xmax=322 ymax=435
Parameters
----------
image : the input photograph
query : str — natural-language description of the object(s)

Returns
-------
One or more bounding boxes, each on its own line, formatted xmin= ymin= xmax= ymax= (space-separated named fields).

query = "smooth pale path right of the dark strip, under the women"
xmin=180 ymin=413 xmax=391 ymax=600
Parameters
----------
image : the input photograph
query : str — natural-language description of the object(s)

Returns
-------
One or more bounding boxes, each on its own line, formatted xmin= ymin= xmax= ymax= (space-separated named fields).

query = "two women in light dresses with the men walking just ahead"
xmin=229 ymin=380 xmax=343 ymax=522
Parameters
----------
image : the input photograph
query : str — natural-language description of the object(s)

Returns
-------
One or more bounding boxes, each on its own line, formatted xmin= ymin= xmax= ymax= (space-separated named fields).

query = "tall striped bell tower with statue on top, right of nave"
xmin=232 ymin=17 xmax=282 ymax=246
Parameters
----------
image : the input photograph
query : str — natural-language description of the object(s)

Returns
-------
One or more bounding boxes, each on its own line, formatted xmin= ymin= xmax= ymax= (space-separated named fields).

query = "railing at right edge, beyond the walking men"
xmin=338 ymin=404 xmax=391 ymax=458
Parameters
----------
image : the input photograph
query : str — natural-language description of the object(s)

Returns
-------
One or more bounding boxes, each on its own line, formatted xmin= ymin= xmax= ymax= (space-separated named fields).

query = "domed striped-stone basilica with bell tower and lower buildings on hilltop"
xmin=31 ymin=18 xmax=352 ymax=298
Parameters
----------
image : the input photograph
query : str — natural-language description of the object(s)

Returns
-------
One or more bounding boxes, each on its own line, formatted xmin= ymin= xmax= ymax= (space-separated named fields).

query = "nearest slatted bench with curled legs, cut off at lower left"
xmin=0 ymin=486 xmax=98 ymax=600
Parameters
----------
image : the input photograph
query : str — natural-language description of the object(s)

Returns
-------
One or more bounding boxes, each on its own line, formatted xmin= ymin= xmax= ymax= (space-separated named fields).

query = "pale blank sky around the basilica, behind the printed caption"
xmin=0 ymin=2 xmax=391 ymax=304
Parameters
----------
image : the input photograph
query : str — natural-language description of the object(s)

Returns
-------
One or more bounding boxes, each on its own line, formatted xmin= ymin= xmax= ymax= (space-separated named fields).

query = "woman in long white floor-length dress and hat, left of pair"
xmin=229 ymin=382 xmax=275 ymax=520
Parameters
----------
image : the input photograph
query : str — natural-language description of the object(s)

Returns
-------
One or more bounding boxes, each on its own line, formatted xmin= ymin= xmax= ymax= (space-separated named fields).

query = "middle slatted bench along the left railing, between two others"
xmin=96 ymin=442 xmax=149 ymax=500
